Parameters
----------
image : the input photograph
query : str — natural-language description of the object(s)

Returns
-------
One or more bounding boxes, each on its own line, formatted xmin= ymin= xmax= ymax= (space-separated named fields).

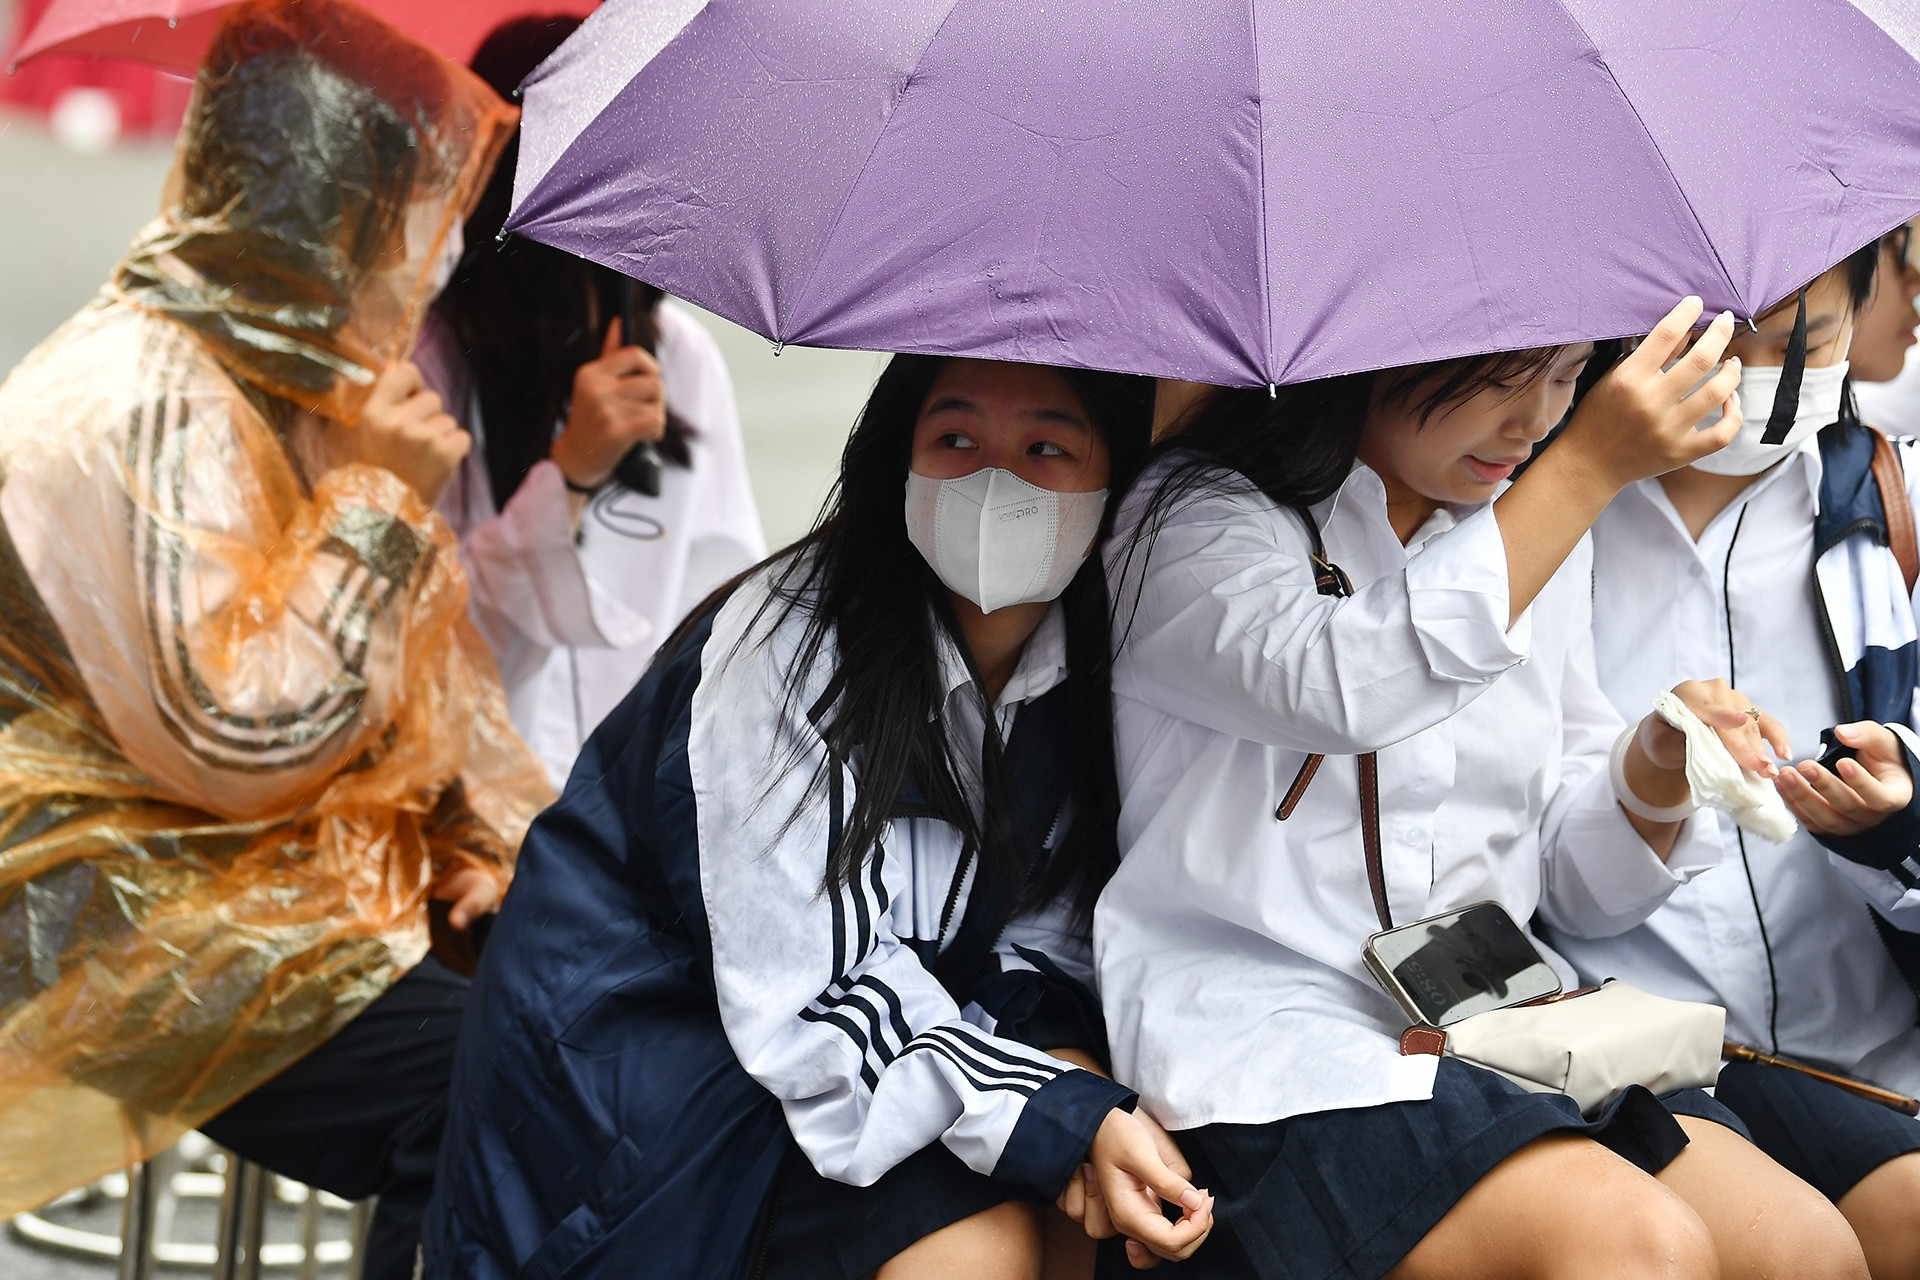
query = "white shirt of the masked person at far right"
xmin=1553 ymin=439 xmax=1920 ymax=1094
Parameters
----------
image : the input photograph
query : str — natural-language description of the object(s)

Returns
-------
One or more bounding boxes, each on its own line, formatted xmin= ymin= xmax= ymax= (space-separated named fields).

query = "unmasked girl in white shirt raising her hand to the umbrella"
xmin=1094 ymin=299 xmax=1864 ymax=1280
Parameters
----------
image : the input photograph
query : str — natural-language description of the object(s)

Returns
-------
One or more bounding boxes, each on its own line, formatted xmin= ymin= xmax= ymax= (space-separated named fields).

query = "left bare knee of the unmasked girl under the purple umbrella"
xmin=1388 ymin=1134 xmax=1720 ymax=1280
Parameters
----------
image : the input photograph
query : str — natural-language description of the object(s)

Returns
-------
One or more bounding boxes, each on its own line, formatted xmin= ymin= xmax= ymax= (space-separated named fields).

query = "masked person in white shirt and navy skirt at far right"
xmin=1542 ymin=244 xmax=1920 ymax=1280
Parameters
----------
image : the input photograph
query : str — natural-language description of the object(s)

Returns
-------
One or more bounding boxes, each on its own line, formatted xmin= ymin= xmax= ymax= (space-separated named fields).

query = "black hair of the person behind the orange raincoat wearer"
xmin=438 ymin=17 xmax=695 ymax=507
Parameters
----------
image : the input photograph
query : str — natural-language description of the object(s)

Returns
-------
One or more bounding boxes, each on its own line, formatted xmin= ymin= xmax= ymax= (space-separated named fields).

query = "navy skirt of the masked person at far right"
xmin=1713 ymin=1063 xmax=1920 ymax=1203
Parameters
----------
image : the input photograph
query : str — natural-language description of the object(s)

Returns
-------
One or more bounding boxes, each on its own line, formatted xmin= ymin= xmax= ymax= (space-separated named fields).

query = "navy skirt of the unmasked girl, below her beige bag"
xmin=1144 ymin=1057 xmax=1745 ymax=1280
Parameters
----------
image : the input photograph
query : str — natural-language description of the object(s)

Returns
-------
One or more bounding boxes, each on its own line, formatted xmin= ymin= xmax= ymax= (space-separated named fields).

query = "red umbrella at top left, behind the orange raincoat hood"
xmin=12 ymin=0 xmax=599 ymax=75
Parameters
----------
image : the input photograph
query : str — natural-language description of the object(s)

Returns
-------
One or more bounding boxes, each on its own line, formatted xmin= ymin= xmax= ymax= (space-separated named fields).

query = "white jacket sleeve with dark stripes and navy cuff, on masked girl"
xmin=687 ymin=589 xmax=1133 ymax=1199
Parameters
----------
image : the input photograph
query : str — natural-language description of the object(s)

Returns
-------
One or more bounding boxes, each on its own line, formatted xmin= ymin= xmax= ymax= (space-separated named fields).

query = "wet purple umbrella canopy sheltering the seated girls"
xmin=509 ymin=0 xmax=1920 ymax=386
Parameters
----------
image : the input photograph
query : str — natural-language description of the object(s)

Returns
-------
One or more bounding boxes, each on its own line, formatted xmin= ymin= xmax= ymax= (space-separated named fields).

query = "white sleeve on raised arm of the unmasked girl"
xmin=1106 ymin=472 xmax=1530 ymax=754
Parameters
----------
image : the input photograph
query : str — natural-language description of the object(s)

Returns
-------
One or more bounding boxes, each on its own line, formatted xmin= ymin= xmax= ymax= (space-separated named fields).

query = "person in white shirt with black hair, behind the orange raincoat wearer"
xmin=415 ymin=17 xmax=766 ymax=787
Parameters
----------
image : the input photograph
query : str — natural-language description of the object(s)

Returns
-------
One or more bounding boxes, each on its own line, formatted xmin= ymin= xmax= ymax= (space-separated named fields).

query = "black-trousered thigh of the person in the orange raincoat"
xmin=200 ymin=960 xmax=468 ymax=1199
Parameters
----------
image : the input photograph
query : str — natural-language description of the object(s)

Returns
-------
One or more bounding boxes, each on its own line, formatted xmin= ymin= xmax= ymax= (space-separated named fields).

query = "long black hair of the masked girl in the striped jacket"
xmin=751 ymin=355 xmax=1152 ymax=919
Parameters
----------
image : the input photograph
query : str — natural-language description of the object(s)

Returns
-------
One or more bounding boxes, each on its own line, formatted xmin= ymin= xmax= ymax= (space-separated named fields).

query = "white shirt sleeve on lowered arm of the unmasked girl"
xmin=1536 ymin=537 xmax=1720 ymax=938
